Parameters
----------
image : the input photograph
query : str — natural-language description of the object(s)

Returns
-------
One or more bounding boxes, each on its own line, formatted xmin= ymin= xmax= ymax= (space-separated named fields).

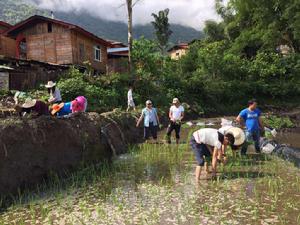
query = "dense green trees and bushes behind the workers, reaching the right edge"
xmin=135 ymin=0 xmax=300 ymax=114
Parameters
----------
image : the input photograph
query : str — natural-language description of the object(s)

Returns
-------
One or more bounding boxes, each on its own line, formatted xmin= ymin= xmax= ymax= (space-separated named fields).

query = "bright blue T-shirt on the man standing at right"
xmin=239 ymin=108 xmax=261 ymax=132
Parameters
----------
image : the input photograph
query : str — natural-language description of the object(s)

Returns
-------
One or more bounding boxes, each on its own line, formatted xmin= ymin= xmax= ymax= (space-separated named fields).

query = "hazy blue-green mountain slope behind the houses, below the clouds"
xmin=0 ymin=0 xmax=202 ymax=43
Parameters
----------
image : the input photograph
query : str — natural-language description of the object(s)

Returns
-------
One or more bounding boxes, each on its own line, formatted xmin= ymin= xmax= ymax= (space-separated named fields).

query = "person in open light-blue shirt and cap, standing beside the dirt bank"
xmin=136 ymin=100 xmax=159 ymax=140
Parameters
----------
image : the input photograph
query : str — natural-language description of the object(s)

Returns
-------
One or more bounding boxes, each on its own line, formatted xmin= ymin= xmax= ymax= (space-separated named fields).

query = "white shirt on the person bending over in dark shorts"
xmin=193 ymin=128 xmax=222 ymax=149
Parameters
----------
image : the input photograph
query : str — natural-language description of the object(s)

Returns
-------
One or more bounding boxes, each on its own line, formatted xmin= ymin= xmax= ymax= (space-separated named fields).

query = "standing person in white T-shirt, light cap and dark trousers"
xmin=167 ymin=98 xmax=184 ymax=144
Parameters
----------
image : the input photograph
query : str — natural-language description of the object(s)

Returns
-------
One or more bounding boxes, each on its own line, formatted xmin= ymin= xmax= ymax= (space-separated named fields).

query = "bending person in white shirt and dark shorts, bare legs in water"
xmin=190 ymin=128 xmax=235 ymax=182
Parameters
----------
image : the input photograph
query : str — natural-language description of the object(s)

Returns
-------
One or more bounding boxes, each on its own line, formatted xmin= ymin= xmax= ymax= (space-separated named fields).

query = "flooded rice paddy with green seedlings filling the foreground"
xmin=0 ymin=125 xmax=300 ymax=225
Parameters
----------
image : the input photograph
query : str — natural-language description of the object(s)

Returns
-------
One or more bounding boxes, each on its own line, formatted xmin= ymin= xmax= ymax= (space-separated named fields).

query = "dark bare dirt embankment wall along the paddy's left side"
xmin=0 ymin=113 xmax=142 ymax=195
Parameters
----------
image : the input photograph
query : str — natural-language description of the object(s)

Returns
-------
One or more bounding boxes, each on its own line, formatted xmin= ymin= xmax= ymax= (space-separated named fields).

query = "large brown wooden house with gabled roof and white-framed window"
xmin=4 ymin=15 xmax=111 ymax=73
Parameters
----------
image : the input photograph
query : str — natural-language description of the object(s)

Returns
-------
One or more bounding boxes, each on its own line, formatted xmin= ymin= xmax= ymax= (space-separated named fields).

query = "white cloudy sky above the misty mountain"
xmin=31 ymin=0 xmax=223 ymax=30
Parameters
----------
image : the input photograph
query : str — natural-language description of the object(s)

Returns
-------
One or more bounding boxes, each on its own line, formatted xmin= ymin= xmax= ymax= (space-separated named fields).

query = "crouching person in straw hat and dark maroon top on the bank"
xmin=15 ymin=98 xmax=49 ymax=116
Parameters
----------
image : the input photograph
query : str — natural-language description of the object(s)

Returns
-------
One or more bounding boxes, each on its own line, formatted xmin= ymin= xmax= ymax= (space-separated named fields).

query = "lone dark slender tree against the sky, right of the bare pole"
xmin=151 ymin=9 xmax=172 ymax=54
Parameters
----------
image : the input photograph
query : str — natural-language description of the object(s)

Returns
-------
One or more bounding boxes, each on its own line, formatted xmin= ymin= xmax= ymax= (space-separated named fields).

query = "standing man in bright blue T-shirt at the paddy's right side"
xmin=236 ymin=99 xmax=263 ymax=155
